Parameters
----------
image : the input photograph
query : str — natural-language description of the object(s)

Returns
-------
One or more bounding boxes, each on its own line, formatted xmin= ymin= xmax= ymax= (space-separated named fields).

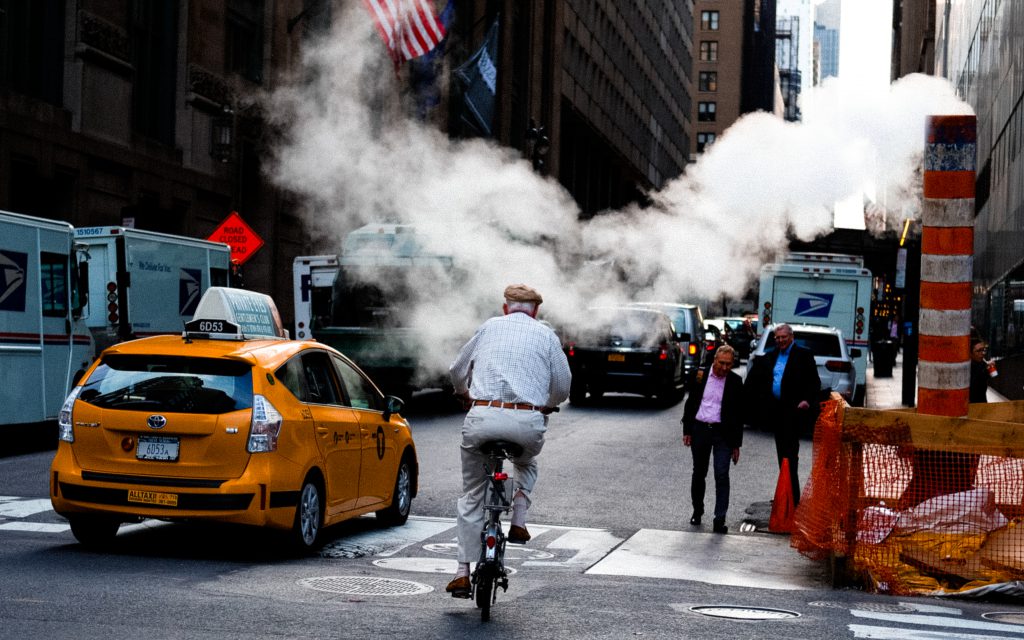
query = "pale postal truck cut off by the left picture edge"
xmin=0 ymin=211 xmax=93 ymax=425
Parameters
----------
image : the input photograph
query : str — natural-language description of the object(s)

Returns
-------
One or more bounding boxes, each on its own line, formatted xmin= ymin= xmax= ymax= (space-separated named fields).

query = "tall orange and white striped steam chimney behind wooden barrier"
xmin=918 ymin=116 xmax=977 ymax=417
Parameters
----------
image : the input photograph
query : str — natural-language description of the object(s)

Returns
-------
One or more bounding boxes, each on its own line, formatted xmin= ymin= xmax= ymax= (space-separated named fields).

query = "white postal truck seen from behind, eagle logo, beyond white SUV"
xmin=760 ymin=252 xmax=872 ymax=407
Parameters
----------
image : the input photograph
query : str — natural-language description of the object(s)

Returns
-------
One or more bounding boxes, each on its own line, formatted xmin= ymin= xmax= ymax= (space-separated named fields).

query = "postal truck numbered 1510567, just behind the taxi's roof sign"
xmin=75 ymin=226 xmax=231 ymax=354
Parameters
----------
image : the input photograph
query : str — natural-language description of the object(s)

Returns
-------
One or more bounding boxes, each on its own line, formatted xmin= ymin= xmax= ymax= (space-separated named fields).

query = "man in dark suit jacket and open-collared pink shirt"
xmin=682 ymin=345 xmax=743 ymax=534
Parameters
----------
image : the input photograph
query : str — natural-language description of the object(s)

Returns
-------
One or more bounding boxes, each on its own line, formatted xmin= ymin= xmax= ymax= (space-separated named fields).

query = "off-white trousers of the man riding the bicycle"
xmin=459 ymin=407 xmax=548 ymax=562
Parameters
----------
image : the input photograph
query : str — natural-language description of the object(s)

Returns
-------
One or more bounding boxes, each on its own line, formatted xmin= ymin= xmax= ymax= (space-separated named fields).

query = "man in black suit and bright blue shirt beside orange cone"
xmin=744 ymin=325 xmax=821 ymax=505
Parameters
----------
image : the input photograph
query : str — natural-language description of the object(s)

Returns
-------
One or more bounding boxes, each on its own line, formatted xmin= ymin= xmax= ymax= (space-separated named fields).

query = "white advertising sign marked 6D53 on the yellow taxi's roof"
xmin=181 ymin=287 xmax=289 ymax=340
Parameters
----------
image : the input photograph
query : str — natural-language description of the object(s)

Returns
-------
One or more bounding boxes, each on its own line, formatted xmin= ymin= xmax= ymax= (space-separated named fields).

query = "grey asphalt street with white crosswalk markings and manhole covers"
xmin=0 ymin=360 xmax=1024 ymax=640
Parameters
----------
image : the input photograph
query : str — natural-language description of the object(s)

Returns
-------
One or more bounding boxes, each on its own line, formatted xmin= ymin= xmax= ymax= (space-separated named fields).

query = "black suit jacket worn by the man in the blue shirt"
xmin=745 ymin=344 xmax=821 ymax=429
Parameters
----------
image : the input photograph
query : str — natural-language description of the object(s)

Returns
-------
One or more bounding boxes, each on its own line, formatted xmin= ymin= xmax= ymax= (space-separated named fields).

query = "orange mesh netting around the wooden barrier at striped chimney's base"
xmin=792 ymin=396 xmax=1024 ymax=595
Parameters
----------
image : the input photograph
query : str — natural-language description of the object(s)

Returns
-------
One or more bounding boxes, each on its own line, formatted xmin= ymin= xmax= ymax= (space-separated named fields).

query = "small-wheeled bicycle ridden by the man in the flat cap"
xmin=470 ymin=440 xmax=522 ymax=622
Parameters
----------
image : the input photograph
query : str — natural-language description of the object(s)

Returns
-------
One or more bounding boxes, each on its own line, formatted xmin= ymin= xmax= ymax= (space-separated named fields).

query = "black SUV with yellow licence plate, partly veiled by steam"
xmin=565 ymin=307 xmax=686 ymax=403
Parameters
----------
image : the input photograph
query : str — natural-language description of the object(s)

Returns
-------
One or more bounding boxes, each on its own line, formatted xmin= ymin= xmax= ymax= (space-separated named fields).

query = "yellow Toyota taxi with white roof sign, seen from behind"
xmin=50 ymin=287 xmax=418 ymax=549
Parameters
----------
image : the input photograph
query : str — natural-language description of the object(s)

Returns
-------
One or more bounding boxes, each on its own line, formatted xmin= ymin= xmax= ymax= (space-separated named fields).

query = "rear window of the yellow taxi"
xmin=78 ymin=355 xmax=253 ymax=414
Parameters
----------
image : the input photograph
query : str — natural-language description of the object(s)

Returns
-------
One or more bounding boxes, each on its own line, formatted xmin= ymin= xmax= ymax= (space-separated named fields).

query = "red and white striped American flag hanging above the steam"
xmin=362 ymin=0 xmax=444 ymax=66
